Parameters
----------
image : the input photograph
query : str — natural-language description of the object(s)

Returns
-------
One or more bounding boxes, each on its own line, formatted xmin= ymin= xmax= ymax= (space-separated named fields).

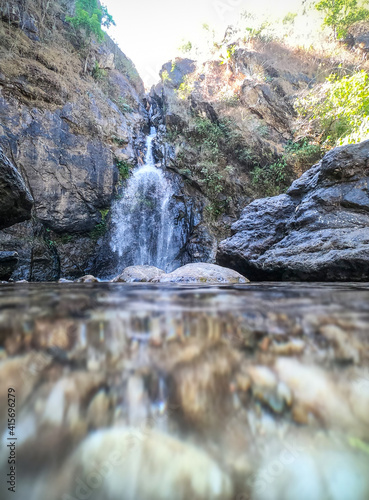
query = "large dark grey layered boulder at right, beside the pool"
xmin=217 ymin=141 xmax=369 ymax=281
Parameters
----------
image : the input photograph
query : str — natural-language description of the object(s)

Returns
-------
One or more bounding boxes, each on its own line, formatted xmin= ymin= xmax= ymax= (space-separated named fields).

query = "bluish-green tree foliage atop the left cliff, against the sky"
xmin=66 ymin=0 xmax=115 ymax=42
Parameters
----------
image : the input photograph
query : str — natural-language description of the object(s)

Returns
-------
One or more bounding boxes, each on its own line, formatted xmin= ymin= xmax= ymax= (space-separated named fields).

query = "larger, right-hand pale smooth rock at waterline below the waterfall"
xmin=159 ymin=262 xmax=249 ymax=283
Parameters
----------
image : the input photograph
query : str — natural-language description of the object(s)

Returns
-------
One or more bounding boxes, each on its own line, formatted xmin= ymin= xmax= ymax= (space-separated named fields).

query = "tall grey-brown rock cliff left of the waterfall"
xmin=0 ymin=0 xmax=147 ymax=280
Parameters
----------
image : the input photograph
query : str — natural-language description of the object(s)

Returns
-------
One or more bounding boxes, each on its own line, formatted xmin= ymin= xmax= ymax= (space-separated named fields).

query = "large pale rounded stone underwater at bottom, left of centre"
xmin=53 ymin=428 xmax=232 ymax=500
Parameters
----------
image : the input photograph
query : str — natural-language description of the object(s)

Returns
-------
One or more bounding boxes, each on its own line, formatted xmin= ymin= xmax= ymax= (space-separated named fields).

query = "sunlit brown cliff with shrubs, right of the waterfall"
xmin=150 ymin=42 xmax=318 ymax=262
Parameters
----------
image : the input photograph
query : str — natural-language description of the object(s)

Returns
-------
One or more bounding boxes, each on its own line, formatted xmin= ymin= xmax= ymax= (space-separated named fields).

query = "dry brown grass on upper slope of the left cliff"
xmin=0 ymin=16 xmax=132 ymax=143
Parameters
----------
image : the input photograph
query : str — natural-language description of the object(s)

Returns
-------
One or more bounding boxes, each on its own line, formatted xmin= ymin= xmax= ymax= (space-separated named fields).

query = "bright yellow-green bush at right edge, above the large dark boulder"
xmin=296 ymin=71 xmax=369 ymax=147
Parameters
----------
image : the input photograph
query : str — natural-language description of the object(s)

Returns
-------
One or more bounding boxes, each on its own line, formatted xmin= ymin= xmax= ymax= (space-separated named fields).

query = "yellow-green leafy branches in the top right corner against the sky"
xmin=315 ymin=0 xmax=369 ymax=39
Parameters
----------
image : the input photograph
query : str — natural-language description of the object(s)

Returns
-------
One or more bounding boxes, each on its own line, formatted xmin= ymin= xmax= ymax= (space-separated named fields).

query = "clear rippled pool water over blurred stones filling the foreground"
xmin=0 ymin=283 xmax=369 ymax=500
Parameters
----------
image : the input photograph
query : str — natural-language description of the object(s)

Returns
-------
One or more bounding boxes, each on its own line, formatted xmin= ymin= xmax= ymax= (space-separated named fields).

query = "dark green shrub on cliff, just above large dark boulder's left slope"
xmin=251 ymin=158 xmax=290 ymax=196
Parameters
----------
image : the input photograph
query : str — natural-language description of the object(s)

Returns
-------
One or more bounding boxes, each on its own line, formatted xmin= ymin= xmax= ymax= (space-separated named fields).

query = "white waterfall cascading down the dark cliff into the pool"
xmin=111 ymin=127 xmax=174 ymax=270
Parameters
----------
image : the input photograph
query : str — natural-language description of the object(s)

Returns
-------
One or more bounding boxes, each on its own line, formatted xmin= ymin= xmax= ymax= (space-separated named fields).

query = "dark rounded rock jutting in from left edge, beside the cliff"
xmin=0 ymin=147 xmax=33 ymax=229
